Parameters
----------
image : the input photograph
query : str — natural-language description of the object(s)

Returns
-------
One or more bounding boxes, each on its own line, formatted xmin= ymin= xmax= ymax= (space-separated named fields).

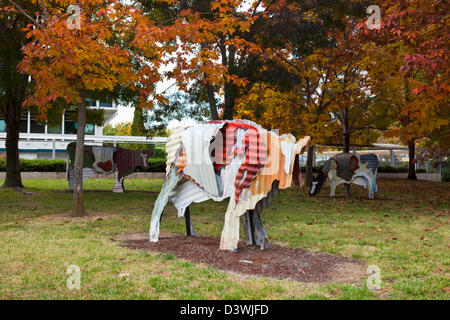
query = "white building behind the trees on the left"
xmin=0 ymin=100 xmax=118 ymax=159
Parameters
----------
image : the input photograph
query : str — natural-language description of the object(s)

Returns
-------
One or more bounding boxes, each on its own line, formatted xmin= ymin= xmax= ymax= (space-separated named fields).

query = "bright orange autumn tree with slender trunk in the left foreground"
xmin=19 ymin=0 xmax=158 ymax=216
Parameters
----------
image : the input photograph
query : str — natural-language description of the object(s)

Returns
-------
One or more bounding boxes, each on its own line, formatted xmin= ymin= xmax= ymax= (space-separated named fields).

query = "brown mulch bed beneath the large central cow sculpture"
xmin=118 ymin=234 xmax=367 ymax=283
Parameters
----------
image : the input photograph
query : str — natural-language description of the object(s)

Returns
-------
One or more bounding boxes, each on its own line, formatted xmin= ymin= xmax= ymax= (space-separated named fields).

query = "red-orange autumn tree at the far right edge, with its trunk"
xmin=361 ymin=0 xmax=450 ymax=179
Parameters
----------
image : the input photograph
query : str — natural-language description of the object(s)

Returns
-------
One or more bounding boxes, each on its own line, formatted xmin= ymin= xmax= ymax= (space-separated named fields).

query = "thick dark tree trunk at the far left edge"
xmin=2 ymin=104 xmax=23 ymax=188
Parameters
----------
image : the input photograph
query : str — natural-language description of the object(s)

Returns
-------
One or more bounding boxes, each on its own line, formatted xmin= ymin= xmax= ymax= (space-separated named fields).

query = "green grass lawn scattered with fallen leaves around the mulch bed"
xmin=0 ymin=179 xmax=450 ymax=299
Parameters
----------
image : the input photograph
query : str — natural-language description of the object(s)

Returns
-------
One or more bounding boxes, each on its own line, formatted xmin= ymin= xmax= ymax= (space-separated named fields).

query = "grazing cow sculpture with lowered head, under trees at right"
xmin=309 ymin=153 xmax=378 ymax=199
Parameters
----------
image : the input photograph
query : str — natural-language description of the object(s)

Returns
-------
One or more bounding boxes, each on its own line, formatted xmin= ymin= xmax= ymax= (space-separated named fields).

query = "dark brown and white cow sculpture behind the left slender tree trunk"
xmin=67 ymin=142 xmax=153 ymax=192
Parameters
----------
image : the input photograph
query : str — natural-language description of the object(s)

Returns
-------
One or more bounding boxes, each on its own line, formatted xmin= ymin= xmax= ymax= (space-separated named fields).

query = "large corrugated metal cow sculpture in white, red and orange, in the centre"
xmin=149 ymin=120 xmax=310 ymax=251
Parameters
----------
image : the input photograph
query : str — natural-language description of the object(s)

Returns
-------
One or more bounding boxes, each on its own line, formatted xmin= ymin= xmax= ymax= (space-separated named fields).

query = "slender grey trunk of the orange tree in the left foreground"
xmin=72 ymin=92 xmax=87 ymax=217
